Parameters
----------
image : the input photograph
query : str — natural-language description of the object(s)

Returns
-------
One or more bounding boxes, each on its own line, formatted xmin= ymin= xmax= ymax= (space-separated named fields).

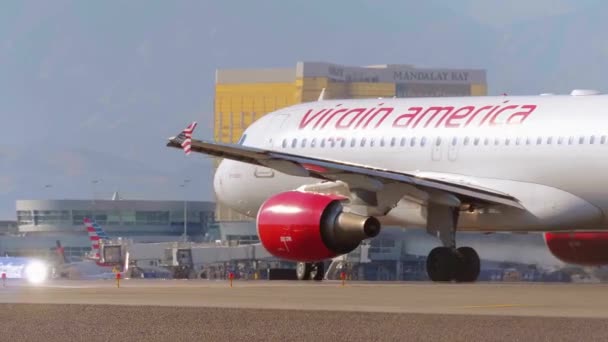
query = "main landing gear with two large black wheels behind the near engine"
xmin=426 ymin=202 xmax=480 ymax=282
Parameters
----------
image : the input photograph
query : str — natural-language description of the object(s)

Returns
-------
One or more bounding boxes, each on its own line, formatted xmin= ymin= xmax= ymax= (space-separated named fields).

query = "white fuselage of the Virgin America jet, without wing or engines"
xmin=214 ymin=95 xmax=608 ymax=231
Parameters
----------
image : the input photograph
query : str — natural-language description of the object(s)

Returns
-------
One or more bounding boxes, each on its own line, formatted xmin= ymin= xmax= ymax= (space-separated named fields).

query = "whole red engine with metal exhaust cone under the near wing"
xmin=257 ymin=191 xmax=381 ymax=262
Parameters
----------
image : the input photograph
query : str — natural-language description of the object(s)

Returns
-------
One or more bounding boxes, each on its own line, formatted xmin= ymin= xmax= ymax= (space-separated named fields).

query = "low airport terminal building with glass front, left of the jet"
xmin=0 ymin=196 xmax=218 ymax=257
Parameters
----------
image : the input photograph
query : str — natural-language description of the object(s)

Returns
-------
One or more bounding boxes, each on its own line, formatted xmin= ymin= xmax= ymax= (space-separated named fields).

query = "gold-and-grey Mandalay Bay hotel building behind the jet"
xmin=214 ymin=62 xmax=487 ymax=221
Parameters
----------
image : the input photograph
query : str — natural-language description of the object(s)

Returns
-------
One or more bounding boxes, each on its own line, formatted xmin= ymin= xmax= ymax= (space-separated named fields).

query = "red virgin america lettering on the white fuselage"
xmin=298 ymin=101 xmax=537 ymax=130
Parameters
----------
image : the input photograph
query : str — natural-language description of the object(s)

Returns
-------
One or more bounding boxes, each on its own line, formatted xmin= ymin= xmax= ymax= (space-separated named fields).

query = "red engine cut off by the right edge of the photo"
xmin=545 ymin=232 xmax=608 ymax=266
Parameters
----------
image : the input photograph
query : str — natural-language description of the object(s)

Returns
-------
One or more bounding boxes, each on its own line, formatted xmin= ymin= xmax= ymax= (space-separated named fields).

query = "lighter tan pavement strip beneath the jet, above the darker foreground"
xmin=0 ymin=280 xmax=608 ymax=318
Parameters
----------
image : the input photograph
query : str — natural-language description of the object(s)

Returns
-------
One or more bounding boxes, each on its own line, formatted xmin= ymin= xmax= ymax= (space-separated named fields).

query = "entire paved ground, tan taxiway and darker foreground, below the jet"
xmin=0 ymin=280 xmax=608 ymax=341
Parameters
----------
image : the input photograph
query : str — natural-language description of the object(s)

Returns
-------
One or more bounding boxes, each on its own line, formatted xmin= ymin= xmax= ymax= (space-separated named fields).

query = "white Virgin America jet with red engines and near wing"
xmin=167 ymin=91 xmax=608 ymax=282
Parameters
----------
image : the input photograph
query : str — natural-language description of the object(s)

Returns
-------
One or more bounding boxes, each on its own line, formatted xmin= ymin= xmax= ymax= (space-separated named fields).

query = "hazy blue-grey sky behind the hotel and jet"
xmin=0 ymin=0 xmax=608 ymax=219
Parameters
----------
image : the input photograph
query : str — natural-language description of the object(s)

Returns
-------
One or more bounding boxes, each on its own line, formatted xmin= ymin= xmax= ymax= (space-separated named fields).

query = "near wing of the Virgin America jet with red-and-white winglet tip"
xmin=167 ymin=127 xmax=524 ymax=209
